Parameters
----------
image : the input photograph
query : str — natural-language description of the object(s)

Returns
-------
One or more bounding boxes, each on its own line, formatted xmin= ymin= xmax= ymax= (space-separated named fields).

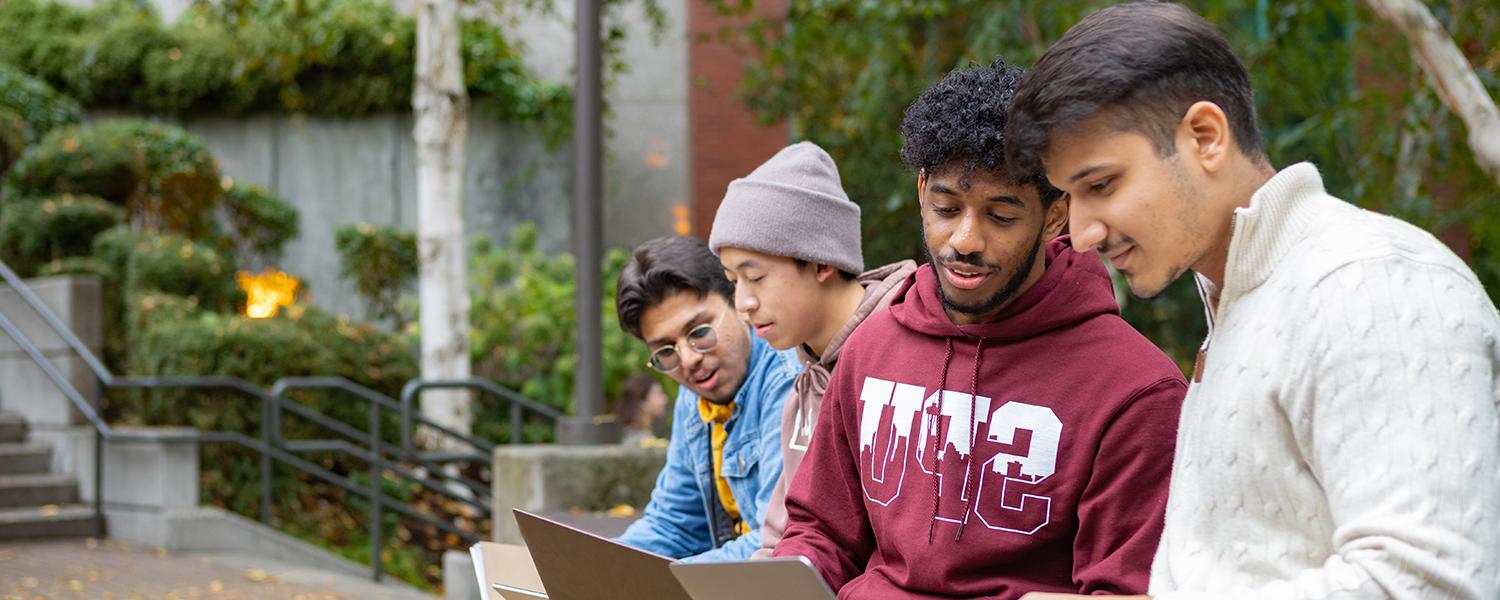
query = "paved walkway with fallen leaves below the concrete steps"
xmin=0 ymin=540 xmax=435 ymax=600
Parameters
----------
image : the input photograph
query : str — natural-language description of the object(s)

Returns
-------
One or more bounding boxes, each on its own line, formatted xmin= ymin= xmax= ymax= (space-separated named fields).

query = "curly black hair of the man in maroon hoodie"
xmin=902 ymin=59 xmax=1062 ymax=206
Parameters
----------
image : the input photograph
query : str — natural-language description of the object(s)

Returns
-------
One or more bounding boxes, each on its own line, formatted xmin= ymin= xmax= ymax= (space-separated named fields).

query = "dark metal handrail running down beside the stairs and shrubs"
xmin=0 ymin=261 xmax=563 ymax=581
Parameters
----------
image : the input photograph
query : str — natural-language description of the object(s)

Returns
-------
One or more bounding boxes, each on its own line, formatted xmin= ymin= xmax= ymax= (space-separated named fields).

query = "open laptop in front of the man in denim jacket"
xmin=507 ymin=509 xmax=692 ymax=600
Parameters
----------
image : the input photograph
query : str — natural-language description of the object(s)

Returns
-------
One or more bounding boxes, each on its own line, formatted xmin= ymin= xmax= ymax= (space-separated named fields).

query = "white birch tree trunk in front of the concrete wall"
xmin=411 ymin=0 xmax=473 ymax=446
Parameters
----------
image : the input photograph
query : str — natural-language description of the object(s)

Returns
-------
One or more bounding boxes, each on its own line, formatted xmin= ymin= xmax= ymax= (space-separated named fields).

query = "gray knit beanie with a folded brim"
xmin=708 ymin=141 xmax=864 ymax=275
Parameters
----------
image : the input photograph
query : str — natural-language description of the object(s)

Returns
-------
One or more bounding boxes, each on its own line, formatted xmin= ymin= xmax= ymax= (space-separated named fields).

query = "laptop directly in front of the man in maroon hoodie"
xmin=671 ymin=557 xmax=834 ymax=600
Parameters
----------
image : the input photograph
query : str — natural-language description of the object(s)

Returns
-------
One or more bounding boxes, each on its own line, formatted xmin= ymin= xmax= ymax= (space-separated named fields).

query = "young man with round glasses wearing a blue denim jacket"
xmin=615 ymin=237 xmax=801 ymax=561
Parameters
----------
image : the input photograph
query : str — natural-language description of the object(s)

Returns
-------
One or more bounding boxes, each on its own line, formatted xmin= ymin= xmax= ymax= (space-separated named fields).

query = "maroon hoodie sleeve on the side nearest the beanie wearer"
xmin=773 ymin=366 xmax=875 ymax=591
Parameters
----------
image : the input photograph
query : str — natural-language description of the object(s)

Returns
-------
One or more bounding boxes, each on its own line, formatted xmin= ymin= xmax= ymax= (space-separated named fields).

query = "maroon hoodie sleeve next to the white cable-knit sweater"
xmin=1073 ymin=377 xmax=1187 ymax=594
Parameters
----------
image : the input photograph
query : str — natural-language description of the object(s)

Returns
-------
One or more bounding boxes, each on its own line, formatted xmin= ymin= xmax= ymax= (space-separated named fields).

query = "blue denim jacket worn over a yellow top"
xmin=618 ymin=333 xmax=803 ymax=563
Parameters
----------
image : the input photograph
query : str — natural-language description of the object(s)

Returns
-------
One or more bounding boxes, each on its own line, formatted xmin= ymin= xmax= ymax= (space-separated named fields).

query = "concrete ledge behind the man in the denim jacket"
xmin=492 ymin=446 xmax=666 ymax=543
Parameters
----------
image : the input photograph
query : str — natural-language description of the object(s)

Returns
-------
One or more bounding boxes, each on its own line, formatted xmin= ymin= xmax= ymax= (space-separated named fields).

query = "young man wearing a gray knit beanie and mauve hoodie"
xmin=708 ymin=141 xmax=917 ymax=558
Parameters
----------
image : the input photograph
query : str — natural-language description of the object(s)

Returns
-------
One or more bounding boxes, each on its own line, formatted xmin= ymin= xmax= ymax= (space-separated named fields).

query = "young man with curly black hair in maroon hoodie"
xmin=776 ymin=60 xmax=1187 ymax=600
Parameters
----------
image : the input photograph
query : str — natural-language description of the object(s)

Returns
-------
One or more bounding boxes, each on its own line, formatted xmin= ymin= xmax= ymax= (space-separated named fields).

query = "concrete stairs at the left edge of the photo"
xmin=0 ymin=413 xmax=96 ymax=540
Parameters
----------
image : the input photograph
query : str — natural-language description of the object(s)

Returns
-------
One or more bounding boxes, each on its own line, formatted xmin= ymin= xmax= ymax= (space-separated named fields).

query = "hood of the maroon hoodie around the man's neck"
xmin=890 ymin=236 xmax=1119 ymax=342
